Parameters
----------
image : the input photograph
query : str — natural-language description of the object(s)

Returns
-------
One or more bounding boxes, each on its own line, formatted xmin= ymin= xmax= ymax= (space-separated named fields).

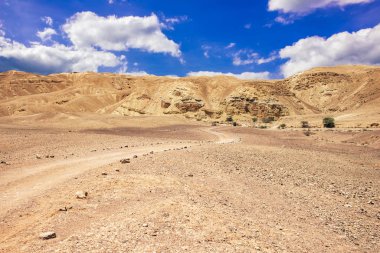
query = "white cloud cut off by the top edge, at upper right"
xmin=268 ymin=0 xmax=374 ymax=14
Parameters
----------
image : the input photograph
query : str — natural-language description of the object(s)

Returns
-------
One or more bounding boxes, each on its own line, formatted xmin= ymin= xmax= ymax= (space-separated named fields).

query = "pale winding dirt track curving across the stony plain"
xmin=0 ymin=128 xmax=239 ymax=217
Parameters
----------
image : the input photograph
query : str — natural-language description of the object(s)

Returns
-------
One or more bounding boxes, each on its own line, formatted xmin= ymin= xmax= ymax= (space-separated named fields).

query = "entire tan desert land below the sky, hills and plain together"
xmin=0 ymin=66 xmax=380 ymax=252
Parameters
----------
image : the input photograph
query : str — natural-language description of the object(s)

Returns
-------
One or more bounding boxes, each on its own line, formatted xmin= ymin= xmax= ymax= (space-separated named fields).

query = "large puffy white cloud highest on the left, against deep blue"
xmin=63 ymin=12 xmax=181 ymax=57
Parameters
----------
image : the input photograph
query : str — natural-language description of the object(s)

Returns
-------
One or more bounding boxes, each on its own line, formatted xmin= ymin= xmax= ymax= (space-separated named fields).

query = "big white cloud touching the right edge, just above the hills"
xmin=280 ymin=24 xmax=380 ymax=77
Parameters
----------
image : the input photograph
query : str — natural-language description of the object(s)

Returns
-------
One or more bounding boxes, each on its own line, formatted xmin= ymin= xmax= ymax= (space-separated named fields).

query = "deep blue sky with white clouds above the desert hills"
xmin=0 ymin=0 xmax=380 ymax=79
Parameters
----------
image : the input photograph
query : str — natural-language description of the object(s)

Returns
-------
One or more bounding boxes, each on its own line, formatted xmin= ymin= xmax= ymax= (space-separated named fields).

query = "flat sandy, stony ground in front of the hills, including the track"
xmin=0 ymin=117 xmax=380 ymax=252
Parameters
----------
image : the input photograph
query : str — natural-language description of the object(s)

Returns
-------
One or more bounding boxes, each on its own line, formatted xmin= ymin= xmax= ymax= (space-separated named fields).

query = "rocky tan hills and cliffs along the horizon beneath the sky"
xmin=0 ymin=66 xmax=380 ymax=124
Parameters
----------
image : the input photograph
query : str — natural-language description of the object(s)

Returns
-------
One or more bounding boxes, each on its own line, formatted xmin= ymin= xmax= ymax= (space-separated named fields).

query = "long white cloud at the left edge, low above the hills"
xmin=0 ymin=32 xmax=121 ymax=73
